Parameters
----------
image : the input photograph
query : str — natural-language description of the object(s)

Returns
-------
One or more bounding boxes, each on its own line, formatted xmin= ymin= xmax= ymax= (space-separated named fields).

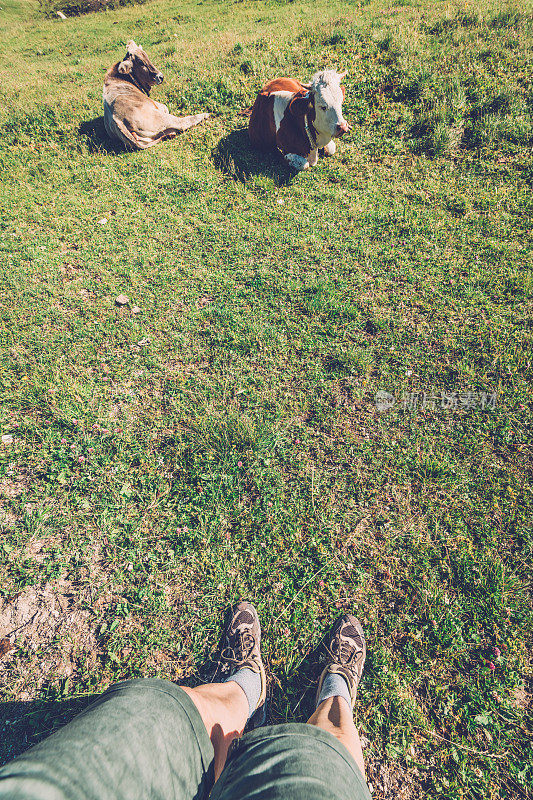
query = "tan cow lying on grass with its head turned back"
xmin=103 ymin=41 xmax=209 ymax=150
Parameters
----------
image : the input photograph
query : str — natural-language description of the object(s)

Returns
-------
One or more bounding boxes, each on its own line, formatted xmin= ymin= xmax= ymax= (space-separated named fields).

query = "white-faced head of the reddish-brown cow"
xmin=291 ymin=69 xmax=349 ymax=139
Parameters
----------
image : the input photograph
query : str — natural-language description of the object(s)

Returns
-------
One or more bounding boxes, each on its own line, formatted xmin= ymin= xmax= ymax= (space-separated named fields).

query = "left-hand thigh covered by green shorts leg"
xmin=0 ymin=679 xmax=214 ymax=800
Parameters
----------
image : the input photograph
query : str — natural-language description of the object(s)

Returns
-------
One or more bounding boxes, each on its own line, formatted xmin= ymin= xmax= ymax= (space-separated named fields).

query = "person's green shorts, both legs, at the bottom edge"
xmin=0 ymin=679 xmax=370 ymax=800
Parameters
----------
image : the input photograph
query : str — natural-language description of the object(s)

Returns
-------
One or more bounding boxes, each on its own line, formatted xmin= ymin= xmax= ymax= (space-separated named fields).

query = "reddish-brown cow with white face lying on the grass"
xmin=248 ymin=69 xmax=349 ymax=170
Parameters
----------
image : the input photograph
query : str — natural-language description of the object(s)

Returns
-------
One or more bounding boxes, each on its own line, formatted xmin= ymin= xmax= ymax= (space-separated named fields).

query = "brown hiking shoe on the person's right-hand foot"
xmin=316 ymin=614 xmax=366 ymax=708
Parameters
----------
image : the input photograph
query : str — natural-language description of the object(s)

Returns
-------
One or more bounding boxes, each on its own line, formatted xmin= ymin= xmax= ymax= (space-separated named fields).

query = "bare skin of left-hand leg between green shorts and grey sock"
xmin=182 ymin=681 xmax=248 ymax=780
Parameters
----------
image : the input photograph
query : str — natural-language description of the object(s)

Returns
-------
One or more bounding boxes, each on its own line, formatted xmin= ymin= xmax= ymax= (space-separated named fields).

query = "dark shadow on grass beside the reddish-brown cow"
xmin=211 ymin=128 xmax=298 ymax=186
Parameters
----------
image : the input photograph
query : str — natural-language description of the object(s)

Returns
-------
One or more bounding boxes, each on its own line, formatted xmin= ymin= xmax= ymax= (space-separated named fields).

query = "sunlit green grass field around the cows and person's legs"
xmin=0 ymin=0 xmax=533 ymax=800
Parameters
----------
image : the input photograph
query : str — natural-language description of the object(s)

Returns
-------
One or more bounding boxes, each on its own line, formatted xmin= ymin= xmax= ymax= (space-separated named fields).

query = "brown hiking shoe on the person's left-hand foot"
xmin=219 ymin=600 xmax=266 ymax=727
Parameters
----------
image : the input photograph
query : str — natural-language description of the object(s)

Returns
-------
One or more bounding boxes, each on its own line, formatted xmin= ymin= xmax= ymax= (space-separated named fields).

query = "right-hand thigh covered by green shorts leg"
xmin=211 ymin=723 xmax=370 ymax=800
